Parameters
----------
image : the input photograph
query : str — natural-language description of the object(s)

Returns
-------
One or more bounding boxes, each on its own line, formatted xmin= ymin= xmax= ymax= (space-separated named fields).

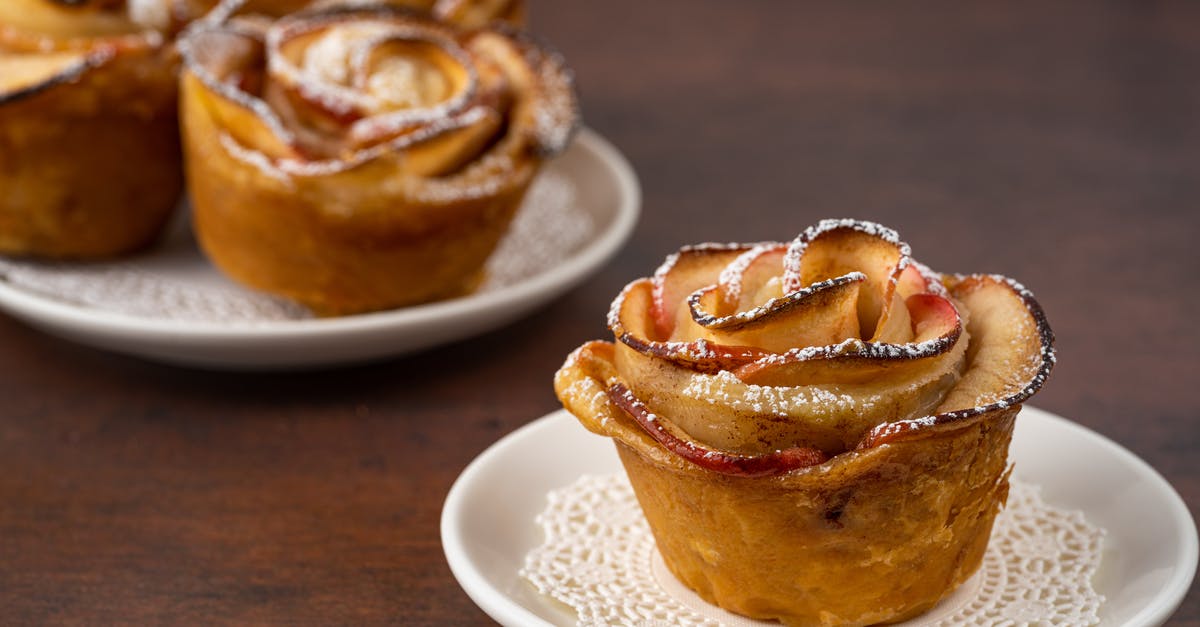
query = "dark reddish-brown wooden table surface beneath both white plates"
xmin=0 ymin=0 xmax=1200 ymax=626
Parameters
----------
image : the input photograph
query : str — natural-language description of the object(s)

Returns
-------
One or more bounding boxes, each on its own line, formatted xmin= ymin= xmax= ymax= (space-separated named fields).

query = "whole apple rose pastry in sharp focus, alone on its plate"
xmin=554 ymin=220 xmax=1054 ymax=625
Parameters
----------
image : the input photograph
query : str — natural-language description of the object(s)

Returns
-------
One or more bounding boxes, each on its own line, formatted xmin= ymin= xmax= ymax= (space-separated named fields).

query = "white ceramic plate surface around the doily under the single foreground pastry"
xmin=442 ymin=407 xmax=1198 ymax=626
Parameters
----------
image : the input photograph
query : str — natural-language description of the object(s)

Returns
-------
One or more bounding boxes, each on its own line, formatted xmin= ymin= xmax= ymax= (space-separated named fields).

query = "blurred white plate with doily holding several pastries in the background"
xmin=0 ymin=130 xmax=641 ymax=370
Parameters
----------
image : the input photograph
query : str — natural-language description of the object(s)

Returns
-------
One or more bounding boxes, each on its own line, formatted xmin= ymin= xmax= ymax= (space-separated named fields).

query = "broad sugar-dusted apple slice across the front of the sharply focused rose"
xmin=613 ymin=307 xmax=967 ymax=454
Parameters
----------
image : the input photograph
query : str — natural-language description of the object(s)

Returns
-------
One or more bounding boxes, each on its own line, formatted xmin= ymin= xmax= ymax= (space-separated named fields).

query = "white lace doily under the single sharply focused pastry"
xmin=521 ymin=474 xmax=1104 ymax=627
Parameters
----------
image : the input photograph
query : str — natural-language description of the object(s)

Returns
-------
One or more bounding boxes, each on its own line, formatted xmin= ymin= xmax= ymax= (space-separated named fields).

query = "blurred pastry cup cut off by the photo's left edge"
xmin=0 ymin=0 xmax=210 ymax=258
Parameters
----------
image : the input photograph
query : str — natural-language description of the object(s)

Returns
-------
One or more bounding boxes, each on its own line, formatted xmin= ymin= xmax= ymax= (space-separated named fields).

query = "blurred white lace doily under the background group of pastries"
xmin=0 ymin=171 xmax=585 ymax=323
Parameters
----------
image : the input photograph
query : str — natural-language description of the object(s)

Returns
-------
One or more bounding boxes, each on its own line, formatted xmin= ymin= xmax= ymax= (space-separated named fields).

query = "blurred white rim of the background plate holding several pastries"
xmin=0 ymin=127 xmax=642 ymax=344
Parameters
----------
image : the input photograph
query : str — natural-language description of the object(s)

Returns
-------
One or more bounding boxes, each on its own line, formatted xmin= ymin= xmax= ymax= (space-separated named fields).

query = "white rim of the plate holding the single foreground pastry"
xmin=439 ymin=405 xmax=1200 ymax=627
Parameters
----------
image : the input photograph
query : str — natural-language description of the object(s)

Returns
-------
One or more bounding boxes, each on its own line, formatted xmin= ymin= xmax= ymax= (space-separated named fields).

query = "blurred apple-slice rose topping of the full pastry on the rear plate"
xmin=181 ymin=5 xmax=575 ymax=178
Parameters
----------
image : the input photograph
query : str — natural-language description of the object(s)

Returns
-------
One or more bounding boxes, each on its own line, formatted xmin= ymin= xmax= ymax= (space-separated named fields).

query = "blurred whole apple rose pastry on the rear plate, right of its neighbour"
xmin=182 ymin=2 xmax=578 ymax=315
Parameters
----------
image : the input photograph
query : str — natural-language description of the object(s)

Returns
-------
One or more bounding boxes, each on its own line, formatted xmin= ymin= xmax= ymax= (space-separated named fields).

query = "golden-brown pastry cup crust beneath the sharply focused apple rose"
xmin=556 ymin=342 xmax=1020 ymax=625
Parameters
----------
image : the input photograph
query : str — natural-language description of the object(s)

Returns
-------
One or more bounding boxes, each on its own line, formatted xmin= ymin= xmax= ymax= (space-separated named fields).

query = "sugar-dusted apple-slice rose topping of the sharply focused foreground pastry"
xmin=590 ymin=219 xmax=1049 ymax=468
